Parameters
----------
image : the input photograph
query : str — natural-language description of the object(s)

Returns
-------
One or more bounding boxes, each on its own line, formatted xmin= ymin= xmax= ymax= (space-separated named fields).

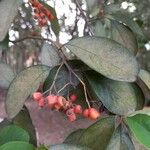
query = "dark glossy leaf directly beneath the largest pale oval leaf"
xmin=86 ymin=71 xmax=144 ymax=115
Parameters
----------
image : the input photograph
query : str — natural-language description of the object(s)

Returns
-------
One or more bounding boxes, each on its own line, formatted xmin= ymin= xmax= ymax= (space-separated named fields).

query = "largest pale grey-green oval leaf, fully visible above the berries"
xmin=65 ymin=37 xmax=139 ymax=82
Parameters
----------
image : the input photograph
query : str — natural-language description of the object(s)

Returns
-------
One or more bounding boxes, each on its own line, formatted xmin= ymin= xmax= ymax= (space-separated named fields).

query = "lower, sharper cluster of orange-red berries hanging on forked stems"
xmin=33 ymin=92 xmax=100 ymax=121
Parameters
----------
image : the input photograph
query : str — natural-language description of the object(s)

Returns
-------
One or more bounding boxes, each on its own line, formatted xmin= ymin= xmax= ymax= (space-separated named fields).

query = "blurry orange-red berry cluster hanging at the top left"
xmin=30 ymin=0 xmax=54 ymax=27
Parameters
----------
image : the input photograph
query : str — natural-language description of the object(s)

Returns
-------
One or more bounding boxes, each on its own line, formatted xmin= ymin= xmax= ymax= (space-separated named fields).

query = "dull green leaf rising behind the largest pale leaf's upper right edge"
xmin=110 ymin=20 xmax=138 ymax=54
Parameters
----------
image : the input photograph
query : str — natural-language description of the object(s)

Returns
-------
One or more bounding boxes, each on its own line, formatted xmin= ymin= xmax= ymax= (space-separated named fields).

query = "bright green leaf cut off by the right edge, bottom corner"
xmin=125 ymin=114 xmax=150 ymax=148
